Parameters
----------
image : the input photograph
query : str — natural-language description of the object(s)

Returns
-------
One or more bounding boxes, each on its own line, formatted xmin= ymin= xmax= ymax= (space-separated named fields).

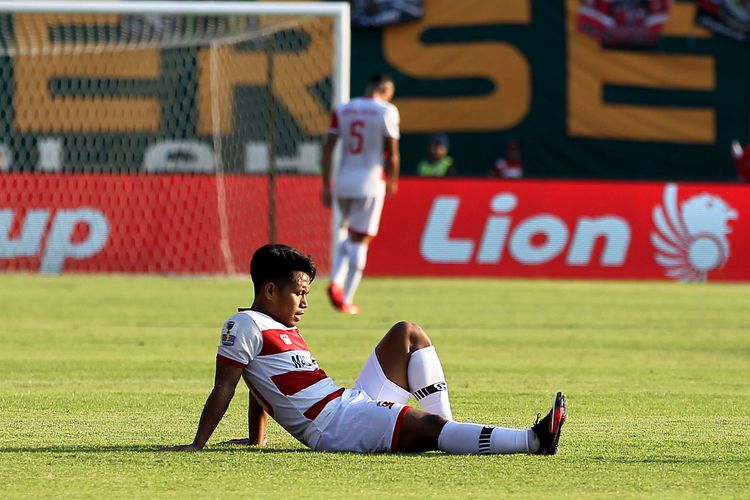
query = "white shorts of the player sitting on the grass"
xmin=313 ymin=351 xmax=410 ymax=453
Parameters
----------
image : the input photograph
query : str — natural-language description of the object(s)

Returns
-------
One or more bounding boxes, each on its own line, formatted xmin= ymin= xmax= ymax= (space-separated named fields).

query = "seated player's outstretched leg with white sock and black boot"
xmin=395 ymin=393 xmax=567 ymax=455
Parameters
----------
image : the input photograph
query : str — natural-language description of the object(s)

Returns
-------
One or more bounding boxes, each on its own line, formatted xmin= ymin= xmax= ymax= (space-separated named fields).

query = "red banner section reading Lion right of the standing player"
xmin=367 ymin=179 xmax=750 ymax=281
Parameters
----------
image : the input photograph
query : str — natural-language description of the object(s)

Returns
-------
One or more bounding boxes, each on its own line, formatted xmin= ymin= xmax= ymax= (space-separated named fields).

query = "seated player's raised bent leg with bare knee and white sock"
xmin=358 ymin=321 xmax=453 ymax=420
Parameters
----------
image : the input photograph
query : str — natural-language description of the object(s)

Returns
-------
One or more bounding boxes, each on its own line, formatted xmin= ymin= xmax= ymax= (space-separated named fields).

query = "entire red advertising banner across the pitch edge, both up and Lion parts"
xmin=0 ymin=174 xmax=750 ymax=281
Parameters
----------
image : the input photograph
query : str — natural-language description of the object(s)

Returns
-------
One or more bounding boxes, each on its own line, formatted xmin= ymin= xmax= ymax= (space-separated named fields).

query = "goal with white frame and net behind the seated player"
xmin=0 ymin=1 xmax=349 ymax=274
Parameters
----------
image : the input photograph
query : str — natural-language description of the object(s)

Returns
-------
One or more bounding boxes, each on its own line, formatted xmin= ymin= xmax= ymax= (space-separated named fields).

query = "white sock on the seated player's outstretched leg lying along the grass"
xmin=438 ymin=422 xmax=539 ymax=455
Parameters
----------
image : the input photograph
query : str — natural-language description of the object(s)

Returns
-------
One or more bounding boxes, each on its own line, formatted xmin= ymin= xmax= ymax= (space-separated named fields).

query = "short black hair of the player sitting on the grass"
xmin=250 ymin=244 xmax=316 ymax=294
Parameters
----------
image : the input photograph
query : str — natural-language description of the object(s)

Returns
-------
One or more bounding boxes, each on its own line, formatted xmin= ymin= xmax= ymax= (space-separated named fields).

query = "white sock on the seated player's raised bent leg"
xmin=406 ymin=346 xmax=453 ymax=420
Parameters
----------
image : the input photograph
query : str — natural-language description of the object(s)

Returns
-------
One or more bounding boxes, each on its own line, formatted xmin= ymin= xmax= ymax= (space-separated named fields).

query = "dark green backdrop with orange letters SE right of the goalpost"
xmin=352 ymin=0 xmax=750 ymax=181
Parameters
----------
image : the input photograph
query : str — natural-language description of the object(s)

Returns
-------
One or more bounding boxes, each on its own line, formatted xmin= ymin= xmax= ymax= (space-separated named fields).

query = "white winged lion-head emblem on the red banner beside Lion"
xmin=651 ymin=184 xmax=738 ymax=281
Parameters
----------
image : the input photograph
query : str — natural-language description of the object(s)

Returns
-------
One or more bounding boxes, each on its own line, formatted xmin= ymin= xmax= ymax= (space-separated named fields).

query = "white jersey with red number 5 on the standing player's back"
xmin=328 ymin=97 xmax=400 ymax=198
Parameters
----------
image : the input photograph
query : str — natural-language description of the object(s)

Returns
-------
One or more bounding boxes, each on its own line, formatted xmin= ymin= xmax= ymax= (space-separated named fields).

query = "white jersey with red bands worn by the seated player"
xmin=216 ymin=310 xmax=345 ymax=447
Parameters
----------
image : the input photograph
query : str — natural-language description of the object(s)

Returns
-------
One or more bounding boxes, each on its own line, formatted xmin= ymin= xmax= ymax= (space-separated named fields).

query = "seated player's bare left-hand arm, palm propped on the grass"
xmin=160 ymin=360 xmax=243 ymax=451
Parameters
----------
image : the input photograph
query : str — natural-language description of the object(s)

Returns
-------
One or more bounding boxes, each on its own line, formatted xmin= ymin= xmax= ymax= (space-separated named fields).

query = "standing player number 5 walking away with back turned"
xmin=321 ymin=74 xmax=400 ymax=314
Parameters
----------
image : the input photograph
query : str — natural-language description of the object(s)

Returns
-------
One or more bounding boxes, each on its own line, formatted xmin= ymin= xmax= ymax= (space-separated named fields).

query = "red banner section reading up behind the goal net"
xmin=0 ymin=174 xmax=330 ymax=274
